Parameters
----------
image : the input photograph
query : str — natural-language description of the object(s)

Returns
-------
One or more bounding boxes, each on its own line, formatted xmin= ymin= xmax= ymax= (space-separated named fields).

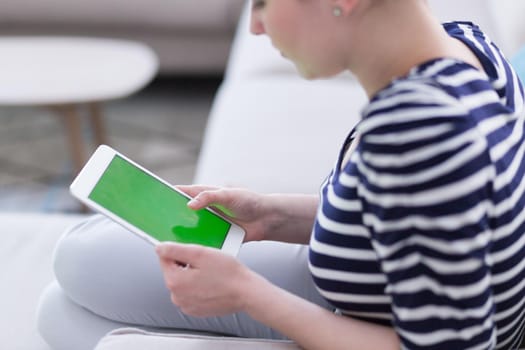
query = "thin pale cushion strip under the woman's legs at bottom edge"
xmin=95 ymin=328 xmax=300 ymax=350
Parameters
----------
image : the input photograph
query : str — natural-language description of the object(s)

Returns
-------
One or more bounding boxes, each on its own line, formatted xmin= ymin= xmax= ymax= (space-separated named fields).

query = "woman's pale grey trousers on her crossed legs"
xmin=38 ymin=216 xmax=329 ymax=350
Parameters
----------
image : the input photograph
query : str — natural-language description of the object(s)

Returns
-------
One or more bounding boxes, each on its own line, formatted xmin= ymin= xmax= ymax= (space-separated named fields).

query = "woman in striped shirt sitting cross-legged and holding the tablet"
xmin=39 ymin=0 xmax=525 ymax=350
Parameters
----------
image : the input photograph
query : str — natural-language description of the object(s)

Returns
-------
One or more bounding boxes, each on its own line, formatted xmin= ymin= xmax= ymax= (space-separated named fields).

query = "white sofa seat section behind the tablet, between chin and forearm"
xmin=190 ymin=76 xmax=366 ymax=193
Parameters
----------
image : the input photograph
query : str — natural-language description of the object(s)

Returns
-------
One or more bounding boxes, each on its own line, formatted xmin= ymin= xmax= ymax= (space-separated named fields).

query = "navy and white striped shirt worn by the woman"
xmin=310 ymin=22 xmax=525 ymax=349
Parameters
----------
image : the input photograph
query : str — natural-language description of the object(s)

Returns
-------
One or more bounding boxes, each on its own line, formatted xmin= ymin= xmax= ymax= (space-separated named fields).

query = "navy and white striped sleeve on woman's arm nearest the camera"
xmin=354 ymin=103 xmax=496 ymax=349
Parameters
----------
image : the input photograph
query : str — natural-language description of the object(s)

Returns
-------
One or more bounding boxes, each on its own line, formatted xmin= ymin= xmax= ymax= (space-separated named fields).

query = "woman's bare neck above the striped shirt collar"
xmin=347 ymin=0 xmax=481 ymax=97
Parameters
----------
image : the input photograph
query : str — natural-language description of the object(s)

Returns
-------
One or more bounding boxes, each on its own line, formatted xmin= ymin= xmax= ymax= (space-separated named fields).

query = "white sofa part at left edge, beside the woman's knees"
xmin=0 ymin=212 xmax=84 ymax=349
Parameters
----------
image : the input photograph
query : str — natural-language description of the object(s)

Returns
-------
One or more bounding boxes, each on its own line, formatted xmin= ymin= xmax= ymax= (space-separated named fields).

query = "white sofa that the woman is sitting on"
xmin=4 ymin=0 xmax=525 ymax=350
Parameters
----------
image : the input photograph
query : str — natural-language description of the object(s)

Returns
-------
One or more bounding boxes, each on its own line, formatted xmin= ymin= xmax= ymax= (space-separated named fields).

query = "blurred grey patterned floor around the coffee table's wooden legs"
xmin=0 ymin=78 xmax=220 ymax=212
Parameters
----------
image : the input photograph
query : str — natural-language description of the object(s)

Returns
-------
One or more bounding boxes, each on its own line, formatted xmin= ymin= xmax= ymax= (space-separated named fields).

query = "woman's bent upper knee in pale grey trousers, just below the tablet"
xmin=54 ymin=216 xmax=166 ymax=316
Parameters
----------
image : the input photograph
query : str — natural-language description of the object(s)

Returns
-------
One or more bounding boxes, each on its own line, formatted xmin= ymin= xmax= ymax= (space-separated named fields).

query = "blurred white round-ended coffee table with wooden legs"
xmin=0 ymin=36 xmax=158 ymax=171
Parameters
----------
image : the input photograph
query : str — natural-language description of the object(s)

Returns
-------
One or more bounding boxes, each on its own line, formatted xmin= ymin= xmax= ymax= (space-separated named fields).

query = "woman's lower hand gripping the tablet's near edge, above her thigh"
xmin=156 ymin=243 xmax=253 ymax=317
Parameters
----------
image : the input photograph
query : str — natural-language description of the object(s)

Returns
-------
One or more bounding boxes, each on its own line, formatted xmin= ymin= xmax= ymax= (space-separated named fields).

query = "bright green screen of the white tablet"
xmin=89 ymin=156 xmax=230 ymax=249
